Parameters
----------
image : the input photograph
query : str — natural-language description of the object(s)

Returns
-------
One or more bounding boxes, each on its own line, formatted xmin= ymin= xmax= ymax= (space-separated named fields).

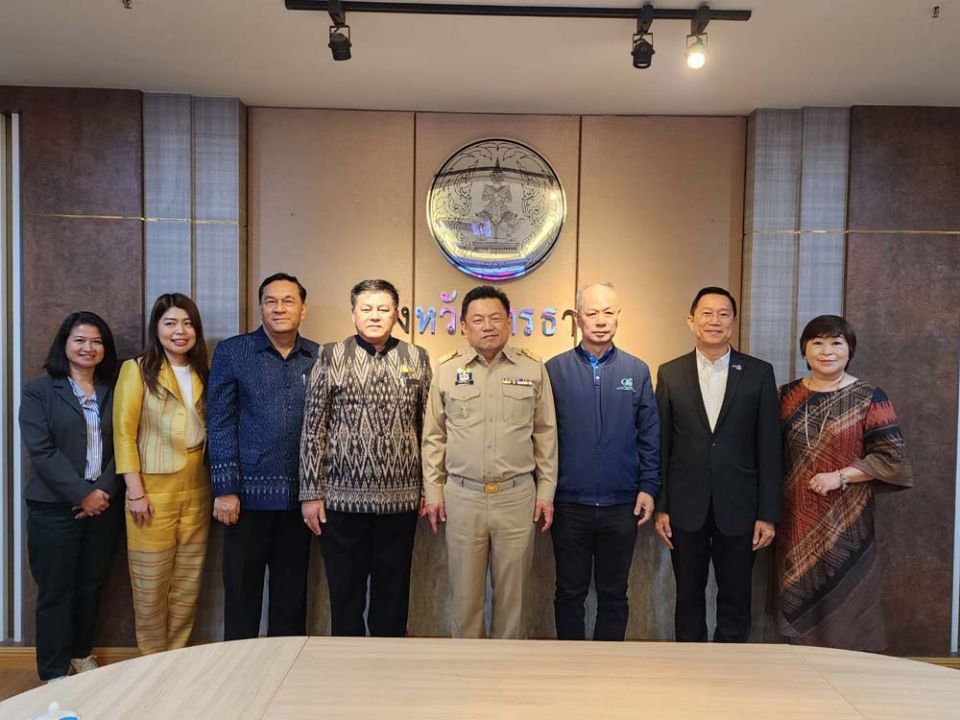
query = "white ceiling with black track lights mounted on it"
xmin=0 ymin=0 xmax=960 ymax=115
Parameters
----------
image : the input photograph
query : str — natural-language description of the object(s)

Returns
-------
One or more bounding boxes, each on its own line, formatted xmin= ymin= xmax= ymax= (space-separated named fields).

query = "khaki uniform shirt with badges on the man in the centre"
xmin=422 ymin=347 xmax=557 ymax=503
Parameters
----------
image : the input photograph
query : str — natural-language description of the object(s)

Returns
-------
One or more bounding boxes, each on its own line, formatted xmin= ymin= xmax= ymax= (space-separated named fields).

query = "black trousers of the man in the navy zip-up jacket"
xmin=551 ymin=503 xmax=637 ymax=640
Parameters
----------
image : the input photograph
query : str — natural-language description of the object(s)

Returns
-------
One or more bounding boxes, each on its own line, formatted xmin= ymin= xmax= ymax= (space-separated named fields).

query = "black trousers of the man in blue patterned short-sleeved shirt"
xmin=223 ymin=508 xmax=313 ymax=640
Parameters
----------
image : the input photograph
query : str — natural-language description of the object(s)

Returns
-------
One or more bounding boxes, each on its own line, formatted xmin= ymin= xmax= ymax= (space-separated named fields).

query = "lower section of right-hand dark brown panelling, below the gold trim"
xmin=847 ymin=233 xmax=960 ymax=655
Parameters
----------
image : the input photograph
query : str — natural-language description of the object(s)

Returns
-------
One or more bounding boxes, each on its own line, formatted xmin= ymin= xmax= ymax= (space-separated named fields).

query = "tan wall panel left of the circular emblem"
xmin=247 ymin=108 xmax=413 ymax=342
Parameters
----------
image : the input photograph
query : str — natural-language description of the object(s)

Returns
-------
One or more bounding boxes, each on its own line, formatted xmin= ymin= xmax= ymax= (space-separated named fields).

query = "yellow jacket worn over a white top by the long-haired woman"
xmin=113 ymin=358 xmax=206 ymax=475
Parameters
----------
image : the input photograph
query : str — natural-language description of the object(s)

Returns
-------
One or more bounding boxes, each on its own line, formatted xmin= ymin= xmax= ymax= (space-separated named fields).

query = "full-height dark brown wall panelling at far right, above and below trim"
xmin=846 ymin=102 xmax=960 ymax=655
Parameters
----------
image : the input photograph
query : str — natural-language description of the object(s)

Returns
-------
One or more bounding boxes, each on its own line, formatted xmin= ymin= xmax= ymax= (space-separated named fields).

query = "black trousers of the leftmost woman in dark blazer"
xmin=27 ymin=495 xmax=123 ymax=680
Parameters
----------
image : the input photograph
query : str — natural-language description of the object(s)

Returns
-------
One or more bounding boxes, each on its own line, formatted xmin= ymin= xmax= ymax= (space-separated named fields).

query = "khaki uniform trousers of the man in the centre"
xmin=443 ymin=476 xmax=537 ymax=638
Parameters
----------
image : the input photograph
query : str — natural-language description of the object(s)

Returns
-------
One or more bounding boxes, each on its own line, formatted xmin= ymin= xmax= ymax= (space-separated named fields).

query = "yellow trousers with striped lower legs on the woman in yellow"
xmin=126 ymin=448 xmax=212 ymax=655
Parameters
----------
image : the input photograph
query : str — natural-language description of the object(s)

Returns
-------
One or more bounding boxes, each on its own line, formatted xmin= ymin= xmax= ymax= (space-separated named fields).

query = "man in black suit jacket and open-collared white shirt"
xmin=655 ymin=287 xmax=783 ymax=642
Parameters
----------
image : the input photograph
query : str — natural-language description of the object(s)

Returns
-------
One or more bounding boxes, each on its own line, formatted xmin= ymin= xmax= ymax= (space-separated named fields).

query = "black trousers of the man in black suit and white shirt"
xmin=670 ymin=505 xmax=755 ymax=642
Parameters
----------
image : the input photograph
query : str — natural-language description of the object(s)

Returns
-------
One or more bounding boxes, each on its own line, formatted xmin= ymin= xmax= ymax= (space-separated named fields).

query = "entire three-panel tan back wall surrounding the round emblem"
xmin=248 ymin=108 xmax=745 ymax=637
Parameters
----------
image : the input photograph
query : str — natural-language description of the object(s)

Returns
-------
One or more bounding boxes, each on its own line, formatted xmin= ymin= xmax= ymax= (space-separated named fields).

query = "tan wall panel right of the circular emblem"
xmin=577 ymin=117 xmax=748 ymax=639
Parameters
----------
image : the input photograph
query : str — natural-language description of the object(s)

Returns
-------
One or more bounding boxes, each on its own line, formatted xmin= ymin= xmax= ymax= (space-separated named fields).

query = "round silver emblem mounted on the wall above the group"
xmin=427 ymin=138 xmax=567 ymax=280
